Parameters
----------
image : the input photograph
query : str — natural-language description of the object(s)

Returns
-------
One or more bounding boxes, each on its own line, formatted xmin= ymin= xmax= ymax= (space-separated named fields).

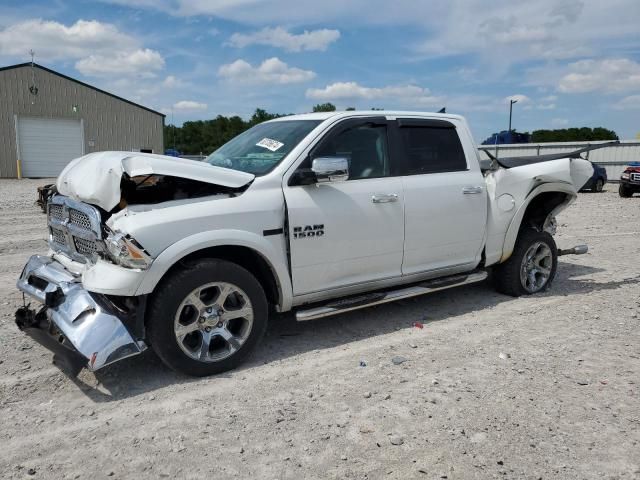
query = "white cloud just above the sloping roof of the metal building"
xmin=76 ymin=48 xmax=164 ymax=78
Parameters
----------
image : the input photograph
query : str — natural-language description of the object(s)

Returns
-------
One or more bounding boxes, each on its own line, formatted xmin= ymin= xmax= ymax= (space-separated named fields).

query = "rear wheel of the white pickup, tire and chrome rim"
xmin=495 ymin=228 xmax=558 ymax=297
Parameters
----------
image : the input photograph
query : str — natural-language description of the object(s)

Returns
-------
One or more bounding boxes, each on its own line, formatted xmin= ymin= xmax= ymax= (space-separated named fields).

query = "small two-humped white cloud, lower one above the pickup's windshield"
xmin=218 ymin=57 xmax=316 ymax=84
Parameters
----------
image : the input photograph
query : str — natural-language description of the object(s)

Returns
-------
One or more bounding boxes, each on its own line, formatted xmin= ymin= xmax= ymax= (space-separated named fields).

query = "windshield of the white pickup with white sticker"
xmin=204 ymin=120 xmax=321 ymax=175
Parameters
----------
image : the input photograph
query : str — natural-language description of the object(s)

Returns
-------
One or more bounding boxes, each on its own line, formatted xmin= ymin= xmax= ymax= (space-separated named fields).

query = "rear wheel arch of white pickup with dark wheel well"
xmin=500 ymin=183 xmax=577 ymax=263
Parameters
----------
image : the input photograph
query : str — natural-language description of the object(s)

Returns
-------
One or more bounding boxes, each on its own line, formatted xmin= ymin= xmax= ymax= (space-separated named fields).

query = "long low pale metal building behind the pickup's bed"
xmin=480 ymin=140 xmax=640 ymax=182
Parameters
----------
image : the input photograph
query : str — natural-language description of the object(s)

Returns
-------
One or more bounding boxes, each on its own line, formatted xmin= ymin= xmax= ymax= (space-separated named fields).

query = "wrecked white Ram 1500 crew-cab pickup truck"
xmin=16 ymin=111 xmax=593 ymax=375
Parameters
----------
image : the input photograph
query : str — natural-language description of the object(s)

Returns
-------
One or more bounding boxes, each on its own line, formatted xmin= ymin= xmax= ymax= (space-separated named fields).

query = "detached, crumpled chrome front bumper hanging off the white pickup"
xmin=16 ymin=255 xmax=146 ymax=371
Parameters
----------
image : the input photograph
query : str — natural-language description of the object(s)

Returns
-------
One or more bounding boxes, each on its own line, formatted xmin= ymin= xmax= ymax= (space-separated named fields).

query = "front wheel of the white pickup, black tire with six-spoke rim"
xmin=146 ymin=259 xmax=269 ymax=377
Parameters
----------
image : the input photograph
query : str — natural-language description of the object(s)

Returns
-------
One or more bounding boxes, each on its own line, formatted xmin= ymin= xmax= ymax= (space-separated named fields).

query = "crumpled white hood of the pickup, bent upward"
xmin=56 ymin=152 xmax=255 ymax=211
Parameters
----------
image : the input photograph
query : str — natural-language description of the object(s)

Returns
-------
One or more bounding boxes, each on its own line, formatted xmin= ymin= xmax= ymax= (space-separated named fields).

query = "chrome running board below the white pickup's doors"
xmin=296 ymin=270 xmax=487 ymax=322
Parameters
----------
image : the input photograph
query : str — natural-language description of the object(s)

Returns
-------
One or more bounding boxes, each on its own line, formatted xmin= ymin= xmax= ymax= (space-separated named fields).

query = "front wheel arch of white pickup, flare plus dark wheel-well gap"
xmin=136 ymin=231 xmax=292 ymax=311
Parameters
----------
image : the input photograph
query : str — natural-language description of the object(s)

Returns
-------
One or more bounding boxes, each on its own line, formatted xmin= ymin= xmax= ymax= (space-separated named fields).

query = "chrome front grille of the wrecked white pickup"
xmin=48 ymin=195 xmax=105 ymax=263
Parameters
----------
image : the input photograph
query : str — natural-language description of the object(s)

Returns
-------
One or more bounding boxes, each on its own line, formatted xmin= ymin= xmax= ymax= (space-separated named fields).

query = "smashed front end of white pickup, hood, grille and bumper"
xmin=16 ymin=152 xmax=255 ymax=371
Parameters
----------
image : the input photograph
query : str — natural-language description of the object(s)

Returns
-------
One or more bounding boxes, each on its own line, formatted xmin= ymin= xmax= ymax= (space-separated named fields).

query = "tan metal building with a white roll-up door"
xmin=0 ymin=63 xmax=164 ymax=178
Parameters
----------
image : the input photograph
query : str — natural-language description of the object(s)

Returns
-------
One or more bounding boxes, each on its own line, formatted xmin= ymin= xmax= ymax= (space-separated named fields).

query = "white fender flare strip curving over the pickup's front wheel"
xmin=135 ymin=230 xmax=292 ymax=311
